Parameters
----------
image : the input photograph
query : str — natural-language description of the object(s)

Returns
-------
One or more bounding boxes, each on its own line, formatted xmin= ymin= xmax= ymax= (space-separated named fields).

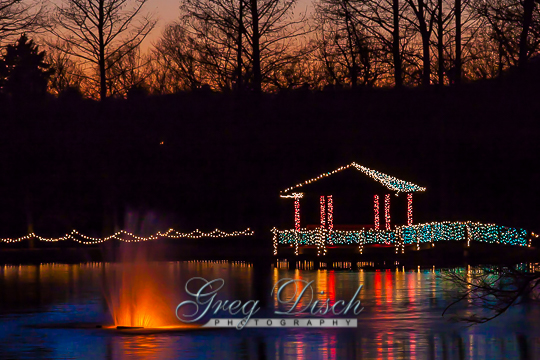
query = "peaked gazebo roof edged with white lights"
xmin=280 ymin=162 xmax=426 ymax=197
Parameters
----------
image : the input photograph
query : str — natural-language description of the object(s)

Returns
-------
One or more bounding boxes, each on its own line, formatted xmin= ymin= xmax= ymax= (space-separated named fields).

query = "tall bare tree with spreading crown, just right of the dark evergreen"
xmin=47 ymin=0 xmax=156 ymax=100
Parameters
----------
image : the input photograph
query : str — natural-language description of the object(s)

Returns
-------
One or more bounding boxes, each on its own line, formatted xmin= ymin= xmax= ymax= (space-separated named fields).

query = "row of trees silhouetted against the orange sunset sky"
xmin=0 ymin=0 xmax=540 ymax=99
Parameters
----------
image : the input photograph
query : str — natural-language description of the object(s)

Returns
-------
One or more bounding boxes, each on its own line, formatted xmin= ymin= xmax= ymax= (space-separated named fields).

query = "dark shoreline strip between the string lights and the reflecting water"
xmin=0 ymin=239 xmax=540 ymax=269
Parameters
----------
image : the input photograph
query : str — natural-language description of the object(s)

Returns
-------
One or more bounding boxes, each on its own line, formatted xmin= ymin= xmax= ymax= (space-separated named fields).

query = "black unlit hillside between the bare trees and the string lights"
xmin=0 ymin=69 xmax=540 ymax=241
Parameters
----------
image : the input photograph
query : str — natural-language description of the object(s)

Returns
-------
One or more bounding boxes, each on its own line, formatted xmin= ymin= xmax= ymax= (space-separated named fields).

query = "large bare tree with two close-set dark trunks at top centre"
xmin=178 ymin=0 xmax=307 ymax=92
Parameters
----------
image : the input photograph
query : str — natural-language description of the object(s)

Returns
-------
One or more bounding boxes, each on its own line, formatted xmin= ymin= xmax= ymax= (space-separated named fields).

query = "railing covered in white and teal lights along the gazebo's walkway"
xmin=271 ymin=221 xmax=538 ymax=255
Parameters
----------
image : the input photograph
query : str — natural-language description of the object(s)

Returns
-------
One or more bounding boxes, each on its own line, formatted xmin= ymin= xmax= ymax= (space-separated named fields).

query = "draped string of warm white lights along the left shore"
xmin=0 ymin=228 xmax=254 ymax=245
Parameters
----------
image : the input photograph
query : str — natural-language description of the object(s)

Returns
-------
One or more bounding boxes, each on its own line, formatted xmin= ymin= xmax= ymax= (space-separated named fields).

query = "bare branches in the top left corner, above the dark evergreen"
xmin=0 ymin=0 xmax=45 ymax=45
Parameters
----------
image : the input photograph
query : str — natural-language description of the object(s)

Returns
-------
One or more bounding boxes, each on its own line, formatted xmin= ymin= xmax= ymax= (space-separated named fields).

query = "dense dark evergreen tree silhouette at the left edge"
xmin=0 ymin=34 xmax=54 ymax=99
